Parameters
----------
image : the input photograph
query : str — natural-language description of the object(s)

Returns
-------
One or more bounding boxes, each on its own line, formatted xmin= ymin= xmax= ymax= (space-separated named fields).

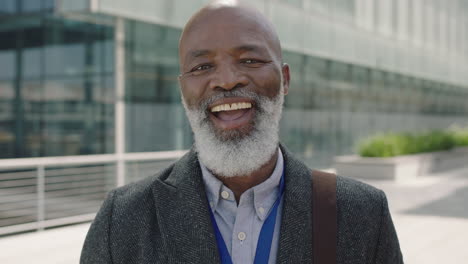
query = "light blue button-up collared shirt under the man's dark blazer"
xmin=200 ymin=148 xmax=284 ymax=264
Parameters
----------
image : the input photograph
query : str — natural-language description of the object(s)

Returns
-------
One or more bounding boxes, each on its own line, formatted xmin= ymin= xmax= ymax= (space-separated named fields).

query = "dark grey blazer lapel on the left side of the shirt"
xmin=153 ymin=150 xmax=220 ymax=263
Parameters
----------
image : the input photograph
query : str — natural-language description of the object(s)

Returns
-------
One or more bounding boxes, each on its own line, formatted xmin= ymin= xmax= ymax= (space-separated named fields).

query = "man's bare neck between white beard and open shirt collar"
xmin=215 ymin=151 xmax=278 ymax=204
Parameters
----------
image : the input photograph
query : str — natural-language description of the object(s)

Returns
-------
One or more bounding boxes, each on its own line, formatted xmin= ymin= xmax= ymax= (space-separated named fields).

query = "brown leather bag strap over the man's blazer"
xmin=312 ymin=171 xmax=337 ymax=264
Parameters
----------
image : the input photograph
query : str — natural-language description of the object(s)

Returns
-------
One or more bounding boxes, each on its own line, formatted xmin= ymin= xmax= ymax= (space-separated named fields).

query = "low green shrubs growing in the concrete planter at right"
xmin=358 ymin=130 xmax=462 ymax=157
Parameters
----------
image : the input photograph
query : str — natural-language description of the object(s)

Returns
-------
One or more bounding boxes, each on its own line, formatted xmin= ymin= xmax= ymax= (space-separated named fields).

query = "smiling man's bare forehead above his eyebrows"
xmin=179 ymin=10 xmax=276 ymax=61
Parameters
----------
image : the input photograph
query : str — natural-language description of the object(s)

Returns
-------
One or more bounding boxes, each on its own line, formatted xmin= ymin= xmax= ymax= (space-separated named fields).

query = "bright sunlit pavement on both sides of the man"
xmin=0 ymin=168 xmax=468 ymax=264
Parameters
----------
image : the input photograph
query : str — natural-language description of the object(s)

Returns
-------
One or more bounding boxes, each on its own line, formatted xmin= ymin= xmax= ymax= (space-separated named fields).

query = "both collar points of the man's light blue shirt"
xmin=200 ymin=148 xmax=284 ymax=220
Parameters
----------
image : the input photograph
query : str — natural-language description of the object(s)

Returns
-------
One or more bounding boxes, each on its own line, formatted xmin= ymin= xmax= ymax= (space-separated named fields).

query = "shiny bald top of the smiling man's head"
xmin=179 ymin=0 xmax=282 ymax=71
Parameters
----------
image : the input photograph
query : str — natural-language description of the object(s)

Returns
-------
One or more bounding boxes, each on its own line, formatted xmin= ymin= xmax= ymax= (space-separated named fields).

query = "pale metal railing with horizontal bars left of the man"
xmin=0 ymin=151 xmax=186 ymax=236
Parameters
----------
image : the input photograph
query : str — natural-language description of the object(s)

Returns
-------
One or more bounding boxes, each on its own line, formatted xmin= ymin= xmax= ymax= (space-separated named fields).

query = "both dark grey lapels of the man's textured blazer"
xmin=153 ymin=145 xmax=312 ymax=263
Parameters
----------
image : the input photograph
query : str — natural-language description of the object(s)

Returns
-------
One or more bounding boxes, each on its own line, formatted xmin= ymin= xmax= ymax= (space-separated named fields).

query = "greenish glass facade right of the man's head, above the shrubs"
xmin=280 ymin=51 xmax=468 ymax=167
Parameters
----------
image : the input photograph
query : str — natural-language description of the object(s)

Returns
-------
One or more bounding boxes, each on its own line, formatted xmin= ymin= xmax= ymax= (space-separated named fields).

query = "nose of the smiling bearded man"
xmin=210 ymin=63 xmax=248 ymax=90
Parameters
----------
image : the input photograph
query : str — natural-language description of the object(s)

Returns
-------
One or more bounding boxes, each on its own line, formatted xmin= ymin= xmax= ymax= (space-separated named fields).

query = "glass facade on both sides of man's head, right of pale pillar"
xmin=120 ymin=20 xmax=468 ymax=167
